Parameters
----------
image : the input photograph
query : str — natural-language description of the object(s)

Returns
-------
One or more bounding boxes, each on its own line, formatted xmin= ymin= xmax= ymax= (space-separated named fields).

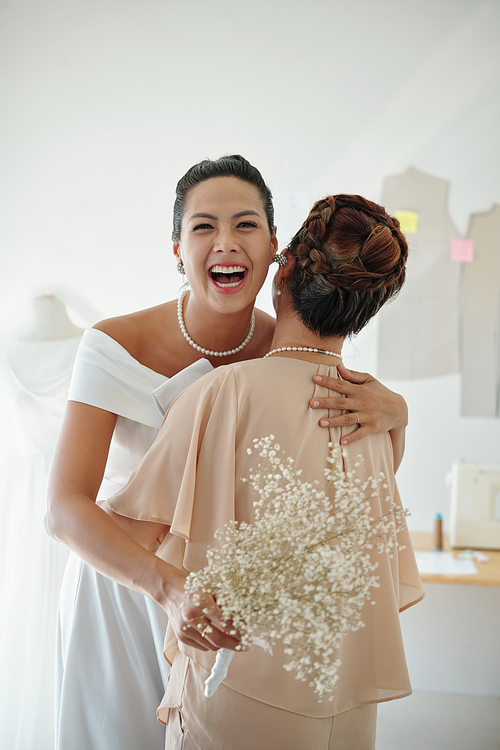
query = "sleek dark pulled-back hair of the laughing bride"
xmin=172 ymin=154 xmax=274 ymax=242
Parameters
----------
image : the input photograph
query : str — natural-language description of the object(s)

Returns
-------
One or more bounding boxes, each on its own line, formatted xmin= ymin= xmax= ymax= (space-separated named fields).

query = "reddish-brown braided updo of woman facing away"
xmin=286 ymin=195 xmax=408 ymax=338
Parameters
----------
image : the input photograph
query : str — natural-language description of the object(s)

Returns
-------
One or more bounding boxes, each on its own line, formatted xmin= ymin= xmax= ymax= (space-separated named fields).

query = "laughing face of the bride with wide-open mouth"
xmin=174 ymin=177 xmax=277 ymax=312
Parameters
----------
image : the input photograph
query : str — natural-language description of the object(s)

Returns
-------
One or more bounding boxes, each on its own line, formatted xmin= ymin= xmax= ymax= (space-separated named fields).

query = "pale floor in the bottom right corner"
xmin=376 ymin=693 xmax=500 ymax=750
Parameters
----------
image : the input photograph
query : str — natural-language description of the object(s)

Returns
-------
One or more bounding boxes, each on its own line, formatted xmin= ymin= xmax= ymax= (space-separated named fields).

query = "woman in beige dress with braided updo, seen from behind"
xmin=103 ymin=195 xmax=423 ymax=750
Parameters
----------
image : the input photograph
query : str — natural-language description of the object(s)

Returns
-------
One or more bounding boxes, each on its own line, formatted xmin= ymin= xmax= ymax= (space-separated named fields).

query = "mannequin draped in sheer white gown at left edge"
xmin=0 ymin=297 xmax=83 ymax=750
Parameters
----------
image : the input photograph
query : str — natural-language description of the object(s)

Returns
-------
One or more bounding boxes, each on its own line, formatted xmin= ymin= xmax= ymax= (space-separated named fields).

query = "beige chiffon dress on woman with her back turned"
xmin=108 ymin=356 xmax=424 ymax=750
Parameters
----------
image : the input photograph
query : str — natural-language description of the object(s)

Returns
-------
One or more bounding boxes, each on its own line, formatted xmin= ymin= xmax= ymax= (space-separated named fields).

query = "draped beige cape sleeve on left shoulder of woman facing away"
xmin=108 ymin=367 xmax=238 ymax=571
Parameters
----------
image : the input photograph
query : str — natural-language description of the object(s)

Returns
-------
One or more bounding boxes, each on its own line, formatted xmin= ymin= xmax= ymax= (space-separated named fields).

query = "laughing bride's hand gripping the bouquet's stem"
xmin=165 ymin=571 xmax=240 ymax=651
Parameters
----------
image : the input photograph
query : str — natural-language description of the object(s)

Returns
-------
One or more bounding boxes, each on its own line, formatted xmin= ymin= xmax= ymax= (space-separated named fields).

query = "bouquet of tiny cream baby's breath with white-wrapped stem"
xmin=186 ymin=435 xmax=406 ymax=700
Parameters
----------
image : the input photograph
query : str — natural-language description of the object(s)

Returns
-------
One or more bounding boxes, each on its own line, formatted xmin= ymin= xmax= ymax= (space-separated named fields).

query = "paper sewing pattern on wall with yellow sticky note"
xmin=378 ymin=167 xmax=460 ymax=380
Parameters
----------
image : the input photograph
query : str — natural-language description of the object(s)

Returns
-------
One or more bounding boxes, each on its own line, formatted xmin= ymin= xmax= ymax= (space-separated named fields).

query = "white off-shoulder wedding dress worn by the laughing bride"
xmin=55 ymin=329 xmax=212 ymax=750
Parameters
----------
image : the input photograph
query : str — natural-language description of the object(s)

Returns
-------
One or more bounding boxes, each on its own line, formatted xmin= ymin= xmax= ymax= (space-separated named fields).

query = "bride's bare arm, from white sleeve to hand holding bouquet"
xmin=46 ymin=401 xmax=238 ymax=651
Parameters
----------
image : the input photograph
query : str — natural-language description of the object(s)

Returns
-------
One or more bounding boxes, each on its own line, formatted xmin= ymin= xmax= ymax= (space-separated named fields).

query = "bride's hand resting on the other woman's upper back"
xmin=310 ymin=365 xmax=408 ymax=445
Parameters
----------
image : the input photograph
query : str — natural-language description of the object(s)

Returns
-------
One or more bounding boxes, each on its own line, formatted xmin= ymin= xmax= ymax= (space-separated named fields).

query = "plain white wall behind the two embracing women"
xmin=0 ymin=0 xmax=500 ymax=529
